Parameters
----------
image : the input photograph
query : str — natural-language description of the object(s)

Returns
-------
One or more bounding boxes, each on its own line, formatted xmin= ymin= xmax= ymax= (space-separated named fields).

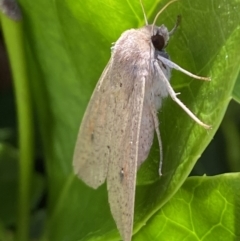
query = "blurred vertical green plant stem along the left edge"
xmin=1 ymin=15 xmax=34 ymax=241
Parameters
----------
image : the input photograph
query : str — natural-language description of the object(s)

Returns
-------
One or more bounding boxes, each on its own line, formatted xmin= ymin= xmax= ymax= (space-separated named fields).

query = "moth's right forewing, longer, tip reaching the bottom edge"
xmin=107 ymin=77 xmax=145 ymax=241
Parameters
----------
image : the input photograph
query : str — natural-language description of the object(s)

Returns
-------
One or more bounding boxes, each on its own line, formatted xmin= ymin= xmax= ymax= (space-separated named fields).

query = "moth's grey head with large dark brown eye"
xmin=151 ymin=25 xmax=169 ymax=51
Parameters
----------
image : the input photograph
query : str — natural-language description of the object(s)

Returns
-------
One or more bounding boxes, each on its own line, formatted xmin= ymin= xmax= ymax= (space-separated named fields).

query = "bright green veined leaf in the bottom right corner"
xmin=133 ymin=174 xmax=240 ymax=241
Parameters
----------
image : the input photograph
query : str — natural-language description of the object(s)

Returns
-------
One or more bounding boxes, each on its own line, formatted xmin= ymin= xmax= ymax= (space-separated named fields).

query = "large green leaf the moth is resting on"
xmin=5 ymin=0 xmax=240 ymax=241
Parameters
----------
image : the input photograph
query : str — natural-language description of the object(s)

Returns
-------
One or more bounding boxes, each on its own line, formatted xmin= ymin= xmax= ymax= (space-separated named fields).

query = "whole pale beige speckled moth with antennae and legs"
xmin=73 ymin=0 xmax=210 ymax=241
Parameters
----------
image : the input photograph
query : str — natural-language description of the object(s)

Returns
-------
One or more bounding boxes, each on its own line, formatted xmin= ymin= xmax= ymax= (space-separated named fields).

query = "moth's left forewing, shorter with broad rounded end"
xmin=73 ymin=60 xmax=112 ymax=188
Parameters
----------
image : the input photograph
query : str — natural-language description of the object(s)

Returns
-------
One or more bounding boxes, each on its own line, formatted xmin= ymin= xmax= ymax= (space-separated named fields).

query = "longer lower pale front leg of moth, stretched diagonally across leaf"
xmin=154 ymin=61 xmax=211 ymax=129
